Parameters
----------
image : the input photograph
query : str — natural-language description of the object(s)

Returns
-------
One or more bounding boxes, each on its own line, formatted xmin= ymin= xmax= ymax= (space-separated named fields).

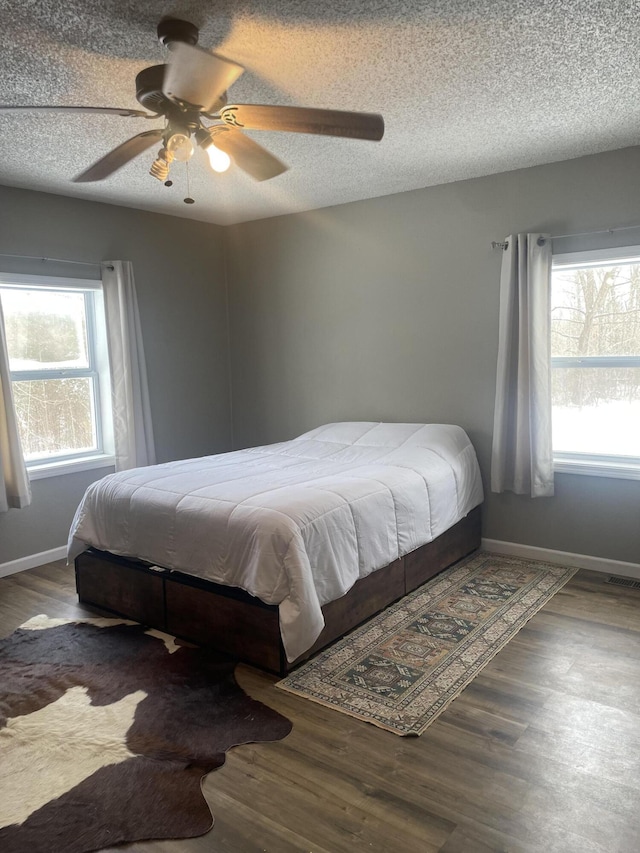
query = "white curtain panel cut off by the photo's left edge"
xmin=0 ymin=296 xmax=31 ymax=512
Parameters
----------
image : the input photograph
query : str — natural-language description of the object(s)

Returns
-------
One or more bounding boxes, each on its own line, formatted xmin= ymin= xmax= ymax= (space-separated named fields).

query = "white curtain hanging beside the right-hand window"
xmin=491 ymin=234 xmax=553 ymax=498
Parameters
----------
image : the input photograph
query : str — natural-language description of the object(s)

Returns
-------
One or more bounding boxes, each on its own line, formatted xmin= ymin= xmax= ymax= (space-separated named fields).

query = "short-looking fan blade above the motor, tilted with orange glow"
xmin=162 ymin=42 xmax=244 ymax=113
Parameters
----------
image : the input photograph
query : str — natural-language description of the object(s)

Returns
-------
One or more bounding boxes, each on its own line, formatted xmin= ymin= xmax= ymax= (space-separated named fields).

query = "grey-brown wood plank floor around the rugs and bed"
xmin=0 ymin=562 xmax=640 ymax=853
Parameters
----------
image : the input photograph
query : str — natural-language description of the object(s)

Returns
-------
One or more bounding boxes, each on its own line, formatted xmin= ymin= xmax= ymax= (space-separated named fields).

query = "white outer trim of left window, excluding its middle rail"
xmin=0 ymin=272 xmax=115 ymax=481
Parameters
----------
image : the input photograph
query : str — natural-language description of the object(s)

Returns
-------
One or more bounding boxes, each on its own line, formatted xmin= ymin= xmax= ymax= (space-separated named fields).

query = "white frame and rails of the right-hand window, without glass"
xmin=549 ymin=245 xmax=640 ymax=480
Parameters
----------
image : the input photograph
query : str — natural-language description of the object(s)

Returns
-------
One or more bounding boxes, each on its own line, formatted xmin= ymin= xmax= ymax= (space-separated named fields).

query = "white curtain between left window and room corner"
xmin=102 ymin=261 xmax=156 ymax=471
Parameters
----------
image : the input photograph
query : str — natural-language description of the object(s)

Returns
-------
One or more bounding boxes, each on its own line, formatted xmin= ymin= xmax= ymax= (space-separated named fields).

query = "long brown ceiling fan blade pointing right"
xmin=220 ymin=104 xmax=384 ymax=141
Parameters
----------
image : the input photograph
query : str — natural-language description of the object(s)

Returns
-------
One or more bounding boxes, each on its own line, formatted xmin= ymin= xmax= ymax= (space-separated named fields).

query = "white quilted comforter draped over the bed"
xmin=68 ymin=422 xmax=483 ymax=661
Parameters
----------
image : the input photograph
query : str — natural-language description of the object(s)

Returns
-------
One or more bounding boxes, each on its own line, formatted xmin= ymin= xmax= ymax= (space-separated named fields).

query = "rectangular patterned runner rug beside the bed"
xmin=277 ymin=552 xmax=577 ymax=735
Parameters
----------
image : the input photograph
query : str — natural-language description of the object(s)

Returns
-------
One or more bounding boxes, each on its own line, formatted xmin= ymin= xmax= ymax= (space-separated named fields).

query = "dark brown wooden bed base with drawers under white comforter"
xmin=75 ymin=507 xmax=480 ymax=675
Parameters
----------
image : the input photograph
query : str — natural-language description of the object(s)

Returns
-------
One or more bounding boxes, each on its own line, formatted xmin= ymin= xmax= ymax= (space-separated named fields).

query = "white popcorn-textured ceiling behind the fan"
xmin=0 ymin=0 xmax=640 ymax=224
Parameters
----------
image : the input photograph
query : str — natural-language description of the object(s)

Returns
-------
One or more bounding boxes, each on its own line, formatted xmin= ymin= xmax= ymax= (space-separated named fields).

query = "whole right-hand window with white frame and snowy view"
xmin=551 ymin=247 xmax=640 ymax=478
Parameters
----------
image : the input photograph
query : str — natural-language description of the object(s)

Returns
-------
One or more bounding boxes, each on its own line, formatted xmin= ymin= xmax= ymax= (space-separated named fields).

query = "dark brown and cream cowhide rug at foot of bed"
xmin=0 ymin=616 xmax=291 ymax=853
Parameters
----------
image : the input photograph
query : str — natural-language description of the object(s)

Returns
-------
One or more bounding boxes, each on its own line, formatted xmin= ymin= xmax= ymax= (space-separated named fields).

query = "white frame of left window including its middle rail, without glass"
xmin=0 ymin=272 xmax=115 ymax=480
